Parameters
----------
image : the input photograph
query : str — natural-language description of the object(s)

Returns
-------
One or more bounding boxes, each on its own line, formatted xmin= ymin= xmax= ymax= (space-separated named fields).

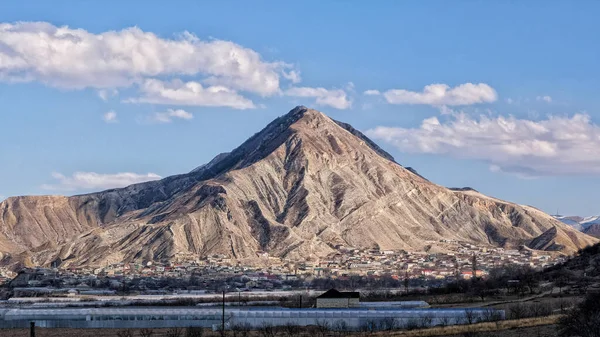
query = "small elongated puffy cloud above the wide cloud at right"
xmin=383 ymin=83 xmax=498 ymax=106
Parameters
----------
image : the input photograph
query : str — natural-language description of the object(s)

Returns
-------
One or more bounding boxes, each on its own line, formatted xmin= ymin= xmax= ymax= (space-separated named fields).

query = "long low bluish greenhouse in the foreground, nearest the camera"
xmin=0 ymin=307 xmax=505 ymax=329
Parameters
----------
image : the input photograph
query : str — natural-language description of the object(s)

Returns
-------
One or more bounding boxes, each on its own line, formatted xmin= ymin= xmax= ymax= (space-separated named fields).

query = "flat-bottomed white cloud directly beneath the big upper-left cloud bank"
xmin=125 ymin=79 xmax=255 ymax=109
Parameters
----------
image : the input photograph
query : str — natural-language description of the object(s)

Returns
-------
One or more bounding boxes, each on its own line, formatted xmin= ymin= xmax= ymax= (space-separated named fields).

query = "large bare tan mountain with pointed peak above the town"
xmin=0 ymin=107 xmax=598 ymax=268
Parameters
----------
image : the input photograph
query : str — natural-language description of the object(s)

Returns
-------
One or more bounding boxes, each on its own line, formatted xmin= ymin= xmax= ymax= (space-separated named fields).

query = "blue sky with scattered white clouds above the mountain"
xmin=0 ymin=1 xmax=600 ymax=215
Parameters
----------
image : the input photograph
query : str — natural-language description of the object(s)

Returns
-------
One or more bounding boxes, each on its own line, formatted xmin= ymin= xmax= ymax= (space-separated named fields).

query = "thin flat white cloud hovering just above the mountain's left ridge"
xmin=41 ymin=172 xmax=161 ymax=191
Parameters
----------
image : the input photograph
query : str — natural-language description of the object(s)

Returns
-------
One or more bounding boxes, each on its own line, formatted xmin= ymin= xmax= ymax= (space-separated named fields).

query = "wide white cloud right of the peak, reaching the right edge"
xmin=367 ymin=113 xmax=600 ymax=177
